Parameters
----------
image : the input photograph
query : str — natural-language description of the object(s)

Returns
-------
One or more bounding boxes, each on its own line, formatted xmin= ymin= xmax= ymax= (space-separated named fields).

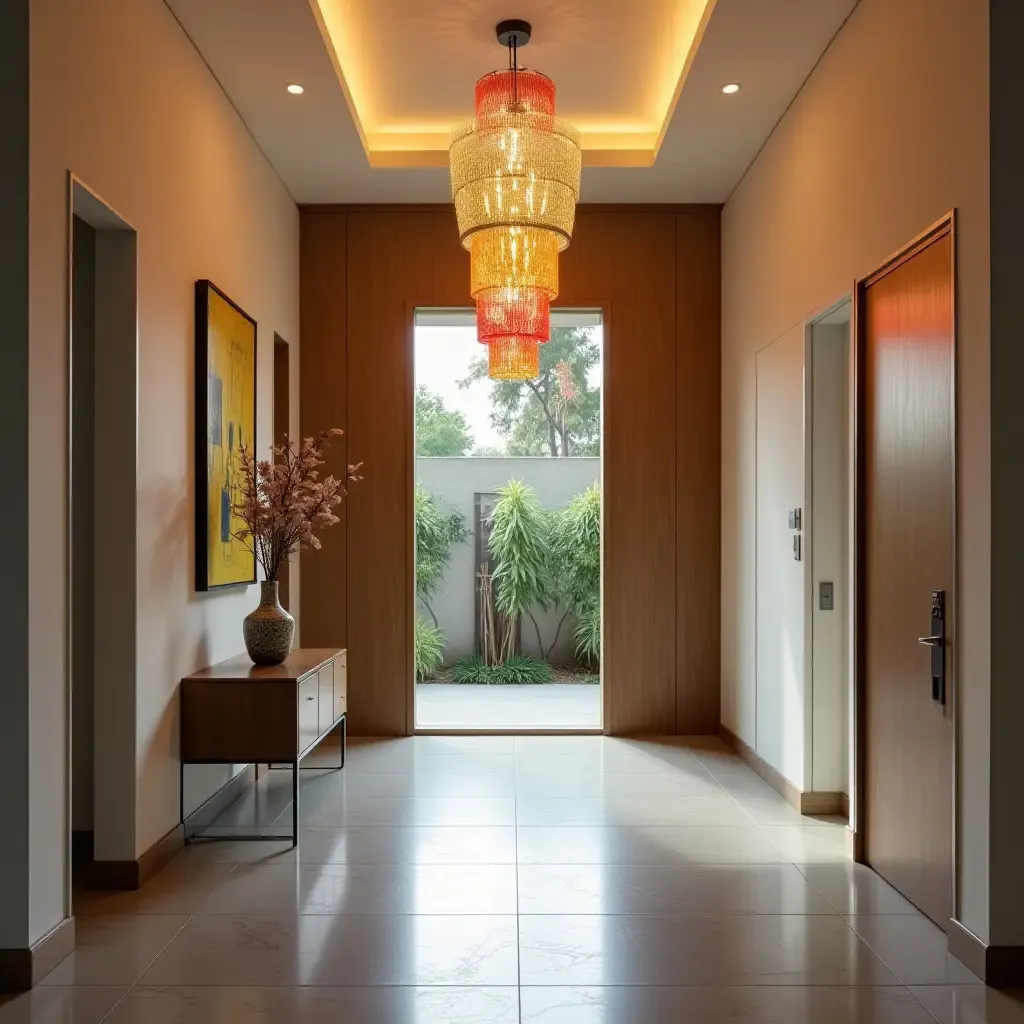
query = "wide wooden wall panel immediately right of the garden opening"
xmin=558 ymin=209 xmax=676 ymax=734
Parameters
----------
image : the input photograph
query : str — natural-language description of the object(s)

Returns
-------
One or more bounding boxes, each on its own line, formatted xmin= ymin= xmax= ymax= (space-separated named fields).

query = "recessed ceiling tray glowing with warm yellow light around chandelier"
xmin=311 ymin=0 xmax=716 ymax=167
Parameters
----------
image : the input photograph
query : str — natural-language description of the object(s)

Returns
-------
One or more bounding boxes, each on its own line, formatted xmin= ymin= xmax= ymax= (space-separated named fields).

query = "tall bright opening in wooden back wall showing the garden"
xmin=413 ymin=309 xmax=603 ymax=732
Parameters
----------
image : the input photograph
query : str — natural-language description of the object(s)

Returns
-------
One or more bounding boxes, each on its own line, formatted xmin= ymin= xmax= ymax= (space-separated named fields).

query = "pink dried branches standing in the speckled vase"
xmin=231 ymin=427 xmax=362 ymax=581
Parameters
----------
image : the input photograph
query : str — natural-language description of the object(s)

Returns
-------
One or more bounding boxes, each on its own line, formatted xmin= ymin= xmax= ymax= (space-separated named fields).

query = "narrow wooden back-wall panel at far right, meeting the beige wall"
xmin=675 ymin=210 xmax=722 ymax=735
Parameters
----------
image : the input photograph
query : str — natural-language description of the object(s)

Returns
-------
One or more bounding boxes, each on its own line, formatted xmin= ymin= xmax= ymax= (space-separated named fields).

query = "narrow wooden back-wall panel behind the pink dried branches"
xmin=299 ymin=212 xmax=348 ymax=647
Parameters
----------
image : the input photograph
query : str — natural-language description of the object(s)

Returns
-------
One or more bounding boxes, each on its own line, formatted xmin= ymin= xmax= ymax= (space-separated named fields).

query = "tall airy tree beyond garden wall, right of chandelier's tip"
xmin=459 ymin=327 xmax=601 ymax=458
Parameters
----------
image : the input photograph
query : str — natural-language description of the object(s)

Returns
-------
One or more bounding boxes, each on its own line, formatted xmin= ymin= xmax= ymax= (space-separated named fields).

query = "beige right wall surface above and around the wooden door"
xmin=722 ymin=0 xmax=990 ymax=938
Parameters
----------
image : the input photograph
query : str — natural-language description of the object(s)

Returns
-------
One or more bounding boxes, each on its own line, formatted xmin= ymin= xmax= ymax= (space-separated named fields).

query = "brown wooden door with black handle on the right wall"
xmin=858 ymin=223 xmax=955 ymax=929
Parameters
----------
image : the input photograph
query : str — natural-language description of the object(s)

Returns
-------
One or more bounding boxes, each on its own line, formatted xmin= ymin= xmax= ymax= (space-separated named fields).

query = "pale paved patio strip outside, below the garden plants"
xmin=416 ymin=683 xmax=601 ymax=729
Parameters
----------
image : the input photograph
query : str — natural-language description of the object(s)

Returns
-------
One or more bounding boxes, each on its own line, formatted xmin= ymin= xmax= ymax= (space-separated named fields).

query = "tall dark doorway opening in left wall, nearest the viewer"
xmin=68 ymin=178 xmax=138 ymax=892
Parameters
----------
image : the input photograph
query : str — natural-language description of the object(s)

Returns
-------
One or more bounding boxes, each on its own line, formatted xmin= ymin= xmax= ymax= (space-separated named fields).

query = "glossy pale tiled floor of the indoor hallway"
xmin=8 ymin=736 xmax=1024 ymax=1024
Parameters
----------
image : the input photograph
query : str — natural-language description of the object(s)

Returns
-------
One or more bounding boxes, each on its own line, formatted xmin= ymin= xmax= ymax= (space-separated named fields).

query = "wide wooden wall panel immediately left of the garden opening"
xmin=348 ymin=210 xmax=469 ymax=735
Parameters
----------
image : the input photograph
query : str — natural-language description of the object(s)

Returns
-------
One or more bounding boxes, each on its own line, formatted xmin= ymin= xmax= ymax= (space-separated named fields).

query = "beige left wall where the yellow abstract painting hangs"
xmin=19 ymin=0 xmax=299 ymax=941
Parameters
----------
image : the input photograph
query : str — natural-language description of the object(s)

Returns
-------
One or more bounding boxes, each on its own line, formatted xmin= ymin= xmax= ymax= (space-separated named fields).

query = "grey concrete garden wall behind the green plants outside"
xmin=416 ymin=458 xmax=601 ymax=665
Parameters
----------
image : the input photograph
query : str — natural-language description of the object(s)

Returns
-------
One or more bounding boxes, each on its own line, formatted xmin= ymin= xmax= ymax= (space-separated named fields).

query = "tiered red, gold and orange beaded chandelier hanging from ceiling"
xmin=449 ymin=20 xmax=582 ymax=380
